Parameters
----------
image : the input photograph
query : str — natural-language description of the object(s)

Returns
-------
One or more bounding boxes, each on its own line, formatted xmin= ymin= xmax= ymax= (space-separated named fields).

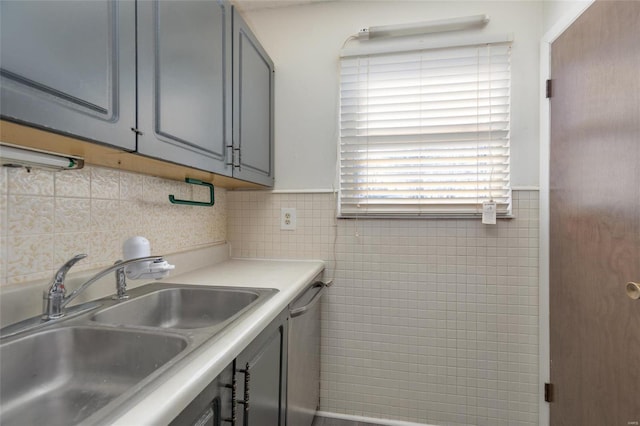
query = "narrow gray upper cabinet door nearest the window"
xmin=233 ymin=9 xmax=274 ymax=186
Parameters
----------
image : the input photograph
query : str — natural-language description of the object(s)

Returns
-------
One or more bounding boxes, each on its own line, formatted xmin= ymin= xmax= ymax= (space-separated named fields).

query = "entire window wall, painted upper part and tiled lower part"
xmin=229 ymin=0 xmax=561 ymax=426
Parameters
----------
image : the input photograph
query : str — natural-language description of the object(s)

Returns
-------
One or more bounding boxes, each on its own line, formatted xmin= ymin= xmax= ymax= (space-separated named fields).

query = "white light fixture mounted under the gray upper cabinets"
xmin=0 ymin=144 xmax=84 ymax=171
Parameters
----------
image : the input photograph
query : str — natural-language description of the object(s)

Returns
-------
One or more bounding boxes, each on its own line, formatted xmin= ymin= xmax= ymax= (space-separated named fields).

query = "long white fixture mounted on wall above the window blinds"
xmin=358 ymin=15 xmax=490 ymax=39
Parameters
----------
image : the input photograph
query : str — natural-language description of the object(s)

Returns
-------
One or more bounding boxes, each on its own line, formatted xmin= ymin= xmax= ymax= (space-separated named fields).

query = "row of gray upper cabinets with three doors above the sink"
xmin=0 ymin=0 xmax=274 ymax=186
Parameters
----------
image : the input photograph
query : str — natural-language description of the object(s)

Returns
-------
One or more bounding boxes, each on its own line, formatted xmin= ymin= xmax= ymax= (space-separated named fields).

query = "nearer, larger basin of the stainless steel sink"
xmin=0 ymin=327 xmax=188 ymax=426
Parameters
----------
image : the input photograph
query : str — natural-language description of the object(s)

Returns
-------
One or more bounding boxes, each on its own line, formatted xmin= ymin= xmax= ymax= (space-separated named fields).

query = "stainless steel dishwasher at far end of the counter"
xmin=287 ymin=275 xmax=332 ymax=426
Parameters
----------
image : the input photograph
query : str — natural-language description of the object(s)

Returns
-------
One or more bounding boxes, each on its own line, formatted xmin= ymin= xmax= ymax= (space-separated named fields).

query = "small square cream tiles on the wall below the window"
xmin=228 ymin=191 xmax=538 ymax=426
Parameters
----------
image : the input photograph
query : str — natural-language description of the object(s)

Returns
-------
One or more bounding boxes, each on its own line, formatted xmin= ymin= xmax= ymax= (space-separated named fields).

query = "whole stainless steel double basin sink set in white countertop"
xmin=0 ymin=284 xmax=277 ymax=426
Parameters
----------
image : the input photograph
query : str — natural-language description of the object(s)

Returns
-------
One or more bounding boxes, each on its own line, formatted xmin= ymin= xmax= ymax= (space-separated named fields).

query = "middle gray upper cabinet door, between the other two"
xmin=138 ymin=0 xmax=231 ymax=175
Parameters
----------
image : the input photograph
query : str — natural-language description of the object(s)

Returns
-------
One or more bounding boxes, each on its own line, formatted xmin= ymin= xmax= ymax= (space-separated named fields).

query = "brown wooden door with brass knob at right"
xmin=550 ymin=1 xmax=640 ymax=426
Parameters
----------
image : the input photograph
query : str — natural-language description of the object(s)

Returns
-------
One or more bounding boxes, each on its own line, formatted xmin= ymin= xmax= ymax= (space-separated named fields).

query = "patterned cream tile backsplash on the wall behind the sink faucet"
xmin=0 ymin=166 xmax=227 ymax=285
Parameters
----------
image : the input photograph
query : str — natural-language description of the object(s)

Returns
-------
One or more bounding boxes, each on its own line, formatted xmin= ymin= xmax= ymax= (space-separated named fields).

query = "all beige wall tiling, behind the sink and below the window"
xmin=0 ymin=175 xmax=539 ymax=426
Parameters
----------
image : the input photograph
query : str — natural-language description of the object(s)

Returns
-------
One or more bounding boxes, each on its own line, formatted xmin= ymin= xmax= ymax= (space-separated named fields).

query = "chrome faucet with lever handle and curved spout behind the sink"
xmin=42 ymin=254 xmax=164 ymax=321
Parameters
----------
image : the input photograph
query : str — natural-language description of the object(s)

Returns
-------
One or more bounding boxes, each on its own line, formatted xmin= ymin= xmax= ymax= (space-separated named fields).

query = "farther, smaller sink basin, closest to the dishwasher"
xmin=92 ymin=286 xmax=260 ymax=329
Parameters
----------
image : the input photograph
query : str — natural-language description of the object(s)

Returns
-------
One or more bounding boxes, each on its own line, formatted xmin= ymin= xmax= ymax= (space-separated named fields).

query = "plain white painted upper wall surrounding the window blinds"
xmin=245 ymin=0 xmax=544 ymax=189
